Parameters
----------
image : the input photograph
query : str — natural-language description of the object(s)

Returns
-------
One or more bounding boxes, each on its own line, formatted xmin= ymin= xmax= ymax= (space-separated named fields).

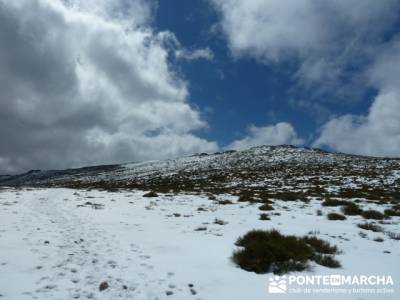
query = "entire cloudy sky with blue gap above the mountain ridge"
xmin=0 ymin=0 xmax=400 ymax=174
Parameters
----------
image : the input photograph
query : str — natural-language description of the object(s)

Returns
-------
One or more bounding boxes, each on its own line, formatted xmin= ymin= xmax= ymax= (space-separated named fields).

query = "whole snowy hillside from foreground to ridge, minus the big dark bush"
xmin=0 ymin=146 xmax=400 ymax=300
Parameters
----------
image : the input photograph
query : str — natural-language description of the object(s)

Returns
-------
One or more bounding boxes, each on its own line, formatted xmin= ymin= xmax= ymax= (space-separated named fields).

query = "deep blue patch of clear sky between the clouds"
xmin=154 ymin=0 xmax=382 ymax=148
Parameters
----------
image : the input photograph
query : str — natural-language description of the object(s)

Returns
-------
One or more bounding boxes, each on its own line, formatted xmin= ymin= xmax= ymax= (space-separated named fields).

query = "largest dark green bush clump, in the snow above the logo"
xmin=232 ymin=230 xmax=340 ymax=274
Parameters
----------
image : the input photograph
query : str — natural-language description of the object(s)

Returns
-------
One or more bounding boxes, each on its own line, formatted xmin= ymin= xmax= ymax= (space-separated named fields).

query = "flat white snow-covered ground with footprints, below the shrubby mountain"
xmin=0 ymin=189 xmax=400 ymax=300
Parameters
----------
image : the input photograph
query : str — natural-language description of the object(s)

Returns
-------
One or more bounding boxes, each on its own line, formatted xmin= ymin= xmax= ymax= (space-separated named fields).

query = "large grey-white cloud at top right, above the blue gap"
xmin=209 ymin=0 xmax=400 ymax=92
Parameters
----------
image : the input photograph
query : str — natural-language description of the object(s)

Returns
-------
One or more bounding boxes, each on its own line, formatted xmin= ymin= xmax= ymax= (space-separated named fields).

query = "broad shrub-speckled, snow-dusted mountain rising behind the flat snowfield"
xmin=0 ymin=145 xmax=400 ymax=198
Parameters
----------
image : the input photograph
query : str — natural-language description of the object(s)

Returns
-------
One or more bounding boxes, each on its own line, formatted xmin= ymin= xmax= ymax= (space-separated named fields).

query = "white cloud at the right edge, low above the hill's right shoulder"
xmin=315 ymin=40 xmax=400 ymax=156
